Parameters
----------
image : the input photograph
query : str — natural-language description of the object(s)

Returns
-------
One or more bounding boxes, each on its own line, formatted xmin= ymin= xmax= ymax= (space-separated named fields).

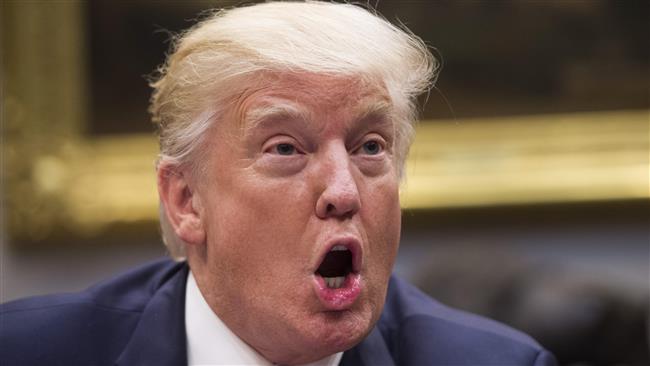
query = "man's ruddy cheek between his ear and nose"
xmin=206 ymin=178 xmax=312 ymax=275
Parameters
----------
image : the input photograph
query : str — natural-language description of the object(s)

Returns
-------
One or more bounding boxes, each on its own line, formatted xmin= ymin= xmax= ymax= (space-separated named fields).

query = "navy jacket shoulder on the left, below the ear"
xmin=0 ymin=259 xmax=183 ymax=365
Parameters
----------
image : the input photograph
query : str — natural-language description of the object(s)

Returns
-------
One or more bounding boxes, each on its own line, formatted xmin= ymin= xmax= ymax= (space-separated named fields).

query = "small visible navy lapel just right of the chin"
xmin=339 ymin=327 xmax=395 ymax=366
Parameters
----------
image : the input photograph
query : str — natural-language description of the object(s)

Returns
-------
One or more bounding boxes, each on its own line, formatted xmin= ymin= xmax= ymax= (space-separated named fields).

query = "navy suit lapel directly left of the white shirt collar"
xmin=115 ymin=265 xmax=188 ymax=366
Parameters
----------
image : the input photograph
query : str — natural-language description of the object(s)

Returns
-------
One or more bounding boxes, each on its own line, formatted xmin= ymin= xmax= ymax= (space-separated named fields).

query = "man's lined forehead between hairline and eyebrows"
xmin=234 ymin=73 xmax=392 ymax=129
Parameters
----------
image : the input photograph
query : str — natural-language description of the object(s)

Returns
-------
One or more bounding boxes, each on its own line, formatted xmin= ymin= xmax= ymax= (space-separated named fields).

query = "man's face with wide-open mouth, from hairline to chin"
xmin=190 ymin=74 xmax=400 ymax=363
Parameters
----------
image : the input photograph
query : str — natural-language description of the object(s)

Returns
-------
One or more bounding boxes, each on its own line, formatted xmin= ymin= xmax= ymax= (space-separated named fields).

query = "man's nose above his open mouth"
xmin=316 ymin=146 xmax=361 ymax=219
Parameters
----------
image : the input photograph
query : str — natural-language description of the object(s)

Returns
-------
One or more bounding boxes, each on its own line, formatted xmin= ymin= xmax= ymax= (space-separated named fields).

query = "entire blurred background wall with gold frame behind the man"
xmin=0 ymin=0 xmax=650 ymax=365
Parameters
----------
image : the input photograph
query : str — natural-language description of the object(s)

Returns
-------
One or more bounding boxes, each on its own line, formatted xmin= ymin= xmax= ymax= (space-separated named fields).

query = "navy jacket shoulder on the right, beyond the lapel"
xmin=378 ymin=277 xmax=555 ymax=365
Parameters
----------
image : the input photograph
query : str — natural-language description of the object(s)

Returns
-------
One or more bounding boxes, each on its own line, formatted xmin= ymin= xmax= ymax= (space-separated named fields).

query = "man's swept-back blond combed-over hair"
xmin=149 ymin=1 xmax=438 ymax=259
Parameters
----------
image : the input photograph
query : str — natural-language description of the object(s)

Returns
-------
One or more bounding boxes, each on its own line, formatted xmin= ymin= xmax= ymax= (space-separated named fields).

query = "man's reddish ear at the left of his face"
xmin=157 ymin=164 xmax=206 ymax=245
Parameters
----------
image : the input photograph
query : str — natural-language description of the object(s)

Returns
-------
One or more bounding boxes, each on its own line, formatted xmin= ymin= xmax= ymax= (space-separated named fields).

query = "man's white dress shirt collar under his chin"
xmin=185 ymin=271 xmax=343 ymax=366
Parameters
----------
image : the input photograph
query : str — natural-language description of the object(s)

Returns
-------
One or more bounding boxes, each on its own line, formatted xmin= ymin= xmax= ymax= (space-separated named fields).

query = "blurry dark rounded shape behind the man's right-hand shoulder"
xmin=417 ymin=244 xmax=649 ymax=366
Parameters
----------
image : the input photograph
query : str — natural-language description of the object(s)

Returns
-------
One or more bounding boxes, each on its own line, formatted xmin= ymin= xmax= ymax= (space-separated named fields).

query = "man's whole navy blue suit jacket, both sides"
xmin=0 ymin=259 xmax=555 ymax=366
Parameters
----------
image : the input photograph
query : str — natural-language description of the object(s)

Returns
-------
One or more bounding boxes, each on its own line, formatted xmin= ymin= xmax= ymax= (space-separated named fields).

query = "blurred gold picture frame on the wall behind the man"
xmin=2 ymin=1 xmax=650 ymax=243
